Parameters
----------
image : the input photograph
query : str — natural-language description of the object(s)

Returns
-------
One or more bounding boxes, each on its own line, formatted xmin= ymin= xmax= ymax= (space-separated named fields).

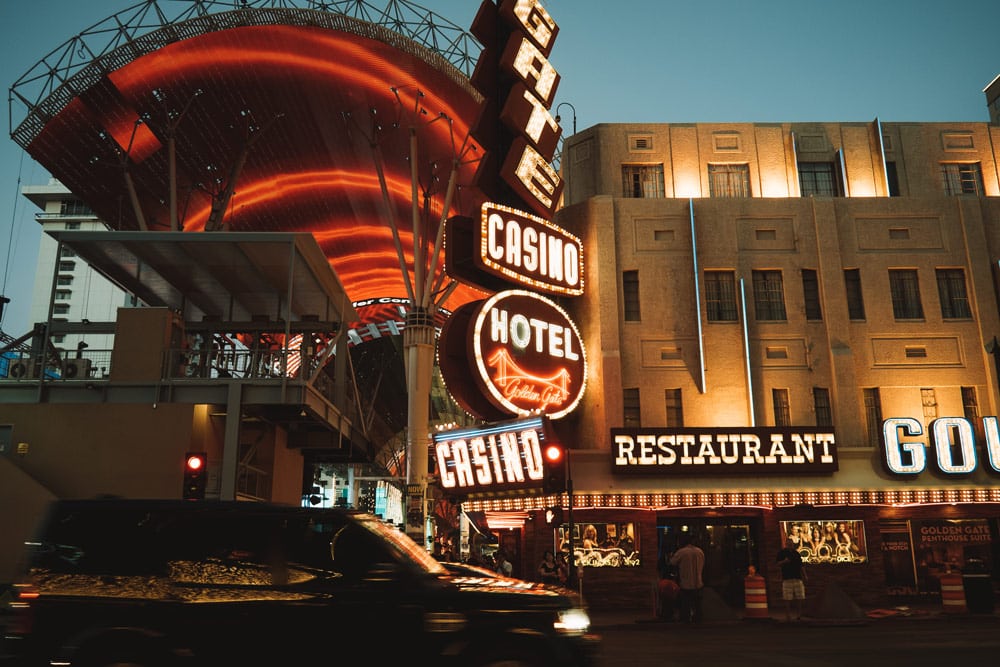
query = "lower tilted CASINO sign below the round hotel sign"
xmin=431 ymin=417 xmax=552 ymax=495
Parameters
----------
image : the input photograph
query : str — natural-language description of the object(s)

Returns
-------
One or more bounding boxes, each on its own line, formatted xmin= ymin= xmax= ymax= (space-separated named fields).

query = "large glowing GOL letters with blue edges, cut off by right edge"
xmin=882 ymin=417 xmax=1000 ymax=475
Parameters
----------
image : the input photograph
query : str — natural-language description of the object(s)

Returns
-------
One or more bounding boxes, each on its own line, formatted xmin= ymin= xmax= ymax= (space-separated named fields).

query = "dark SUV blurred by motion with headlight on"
xmin=4 ymin=499 xmax=600 ymax=667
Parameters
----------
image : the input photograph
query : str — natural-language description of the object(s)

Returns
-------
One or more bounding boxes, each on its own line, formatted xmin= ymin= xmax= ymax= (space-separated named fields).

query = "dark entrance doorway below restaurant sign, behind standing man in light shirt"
xmin=656 ymin=517 xmax=761 ymax=608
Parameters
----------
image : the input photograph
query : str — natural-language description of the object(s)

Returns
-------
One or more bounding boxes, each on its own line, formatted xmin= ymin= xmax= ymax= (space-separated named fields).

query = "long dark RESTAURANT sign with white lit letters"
xmin=611 ymin=426 xmax=837 ymax=475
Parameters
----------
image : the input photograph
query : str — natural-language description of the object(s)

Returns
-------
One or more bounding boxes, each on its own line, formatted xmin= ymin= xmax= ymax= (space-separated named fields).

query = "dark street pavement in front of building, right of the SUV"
xmin=591 ymin=599 xmax=1000 ymax=667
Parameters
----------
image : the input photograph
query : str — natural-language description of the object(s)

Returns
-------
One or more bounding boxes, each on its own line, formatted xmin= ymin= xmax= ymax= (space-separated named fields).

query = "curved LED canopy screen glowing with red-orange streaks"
xmin=21 ymin=10 xmax=483 ymax=320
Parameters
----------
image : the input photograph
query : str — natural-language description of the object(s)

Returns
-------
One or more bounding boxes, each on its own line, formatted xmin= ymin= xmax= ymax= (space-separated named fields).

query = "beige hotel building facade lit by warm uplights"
xmin=472 ymin=120 xmax=1000 ymax=608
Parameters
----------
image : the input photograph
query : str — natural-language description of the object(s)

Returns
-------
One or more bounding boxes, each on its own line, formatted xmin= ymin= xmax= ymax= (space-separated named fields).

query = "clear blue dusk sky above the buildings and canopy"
xmin=0 ymin=0 xmax=1000 ymax=336
